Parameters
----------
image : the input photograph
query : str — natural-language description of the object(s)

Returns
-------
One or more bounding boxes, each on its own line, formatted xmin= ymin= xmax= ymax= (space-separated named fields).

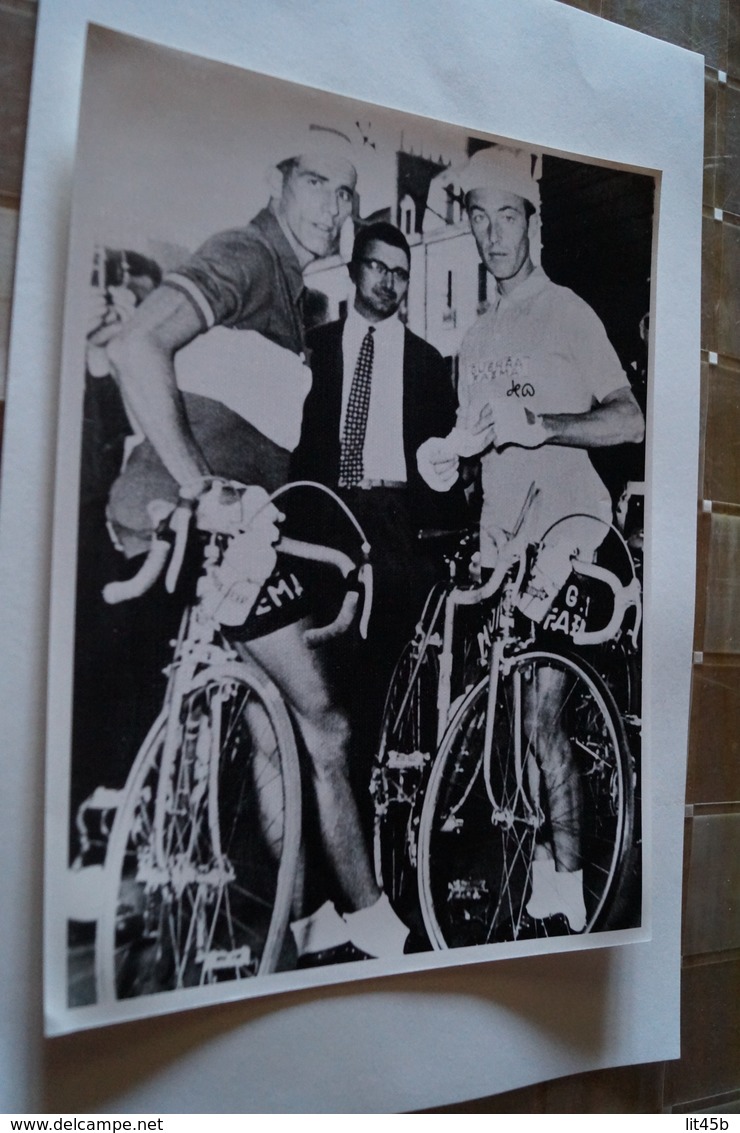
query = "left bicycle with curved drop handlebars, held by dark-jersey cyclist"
xmin=89 ymin=482 xmax=372 ymax=1002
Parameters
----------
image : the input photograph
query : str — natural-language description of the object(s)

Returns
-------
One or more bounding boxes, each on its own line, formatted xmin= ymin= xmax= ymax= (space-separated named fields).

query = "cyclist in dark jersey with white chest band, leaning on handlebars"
xmin=109 ymin=128 xmax=407 ymax=963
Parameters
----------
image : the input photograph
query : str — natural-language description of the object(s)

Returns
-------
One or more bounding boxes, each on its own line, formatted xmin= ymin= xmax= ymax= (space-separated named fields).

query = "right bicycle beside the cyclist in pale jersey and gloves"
xmin=373 ymin=500 xmax=641 ymax=948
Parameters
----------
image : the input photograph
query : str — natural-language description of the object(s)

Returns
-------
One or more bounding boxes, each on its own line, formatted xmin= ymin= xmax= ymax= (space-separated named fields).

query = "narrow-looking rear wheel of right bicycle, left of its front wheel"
xmin=371 ymin=641 xmax=439 ymax=922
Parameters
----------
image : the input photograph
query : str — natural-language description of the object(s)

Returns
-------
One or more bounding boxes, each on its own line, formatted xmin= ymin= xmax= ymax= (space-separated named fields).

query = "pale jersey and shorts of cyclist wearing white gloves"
xmin=458 ymin=267 xmax=629 ymax=565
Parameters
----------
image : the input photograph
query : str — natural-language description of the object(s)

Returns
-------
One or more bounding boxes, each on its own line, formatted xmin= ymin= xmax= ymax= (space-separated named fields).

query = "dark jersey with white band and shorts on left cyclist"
xmin=109 ymin=208 xmax=311 ymax=555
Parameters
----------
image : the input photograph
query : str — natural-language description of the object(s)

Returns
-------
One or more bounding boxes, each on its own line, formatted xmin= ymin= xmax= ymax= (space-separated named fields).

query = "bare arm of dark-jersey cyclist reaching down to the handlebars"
xmin=108 ymin=287 xmax=210 ymax=485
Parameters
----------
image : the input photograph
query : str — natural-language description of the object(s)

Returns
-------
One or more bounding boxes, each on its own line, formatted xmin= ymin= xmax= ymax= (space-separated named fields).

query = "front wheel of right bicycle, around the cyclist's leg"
xmin=419 ymin=649 xmax=635 ymax=949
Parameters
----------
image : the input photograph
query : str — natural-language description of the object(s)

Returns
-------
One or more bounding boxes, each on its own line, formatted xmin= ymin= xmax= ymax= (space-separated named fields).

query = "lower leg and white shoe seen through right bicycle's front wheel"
xmin=525 ymin=665 xmax=586 ymax=930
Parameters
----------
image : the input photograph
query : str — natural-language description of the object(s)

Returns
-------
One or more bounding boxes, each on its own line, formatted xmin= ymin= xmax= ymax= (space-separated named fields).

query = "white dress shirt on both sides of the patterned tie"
xmin=340 ymin=307 xmax=406 ymax=482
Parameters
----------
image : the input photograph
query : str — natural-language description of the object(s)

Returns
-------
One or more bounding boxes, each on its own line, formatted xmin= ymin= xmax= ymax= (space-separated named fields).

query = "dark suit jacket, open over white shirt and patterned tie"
xmin=291 ymin=321 xmax=466 ymax=530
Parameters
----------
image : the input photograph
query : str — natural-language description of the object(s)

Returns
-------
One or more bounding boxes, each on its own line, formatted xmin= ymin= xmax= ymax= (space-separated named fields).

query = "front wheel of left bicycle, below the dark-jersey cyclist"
xmin=95 ymin=662 xmax=301 ymax=1002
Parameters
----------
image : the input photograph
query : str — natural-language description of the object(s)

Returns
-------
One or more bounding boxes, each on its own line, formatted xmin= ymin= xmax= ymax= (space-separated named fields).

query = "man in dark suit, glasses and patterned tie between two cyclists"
xmin=291 ymin=222 xmax=465 ymax=742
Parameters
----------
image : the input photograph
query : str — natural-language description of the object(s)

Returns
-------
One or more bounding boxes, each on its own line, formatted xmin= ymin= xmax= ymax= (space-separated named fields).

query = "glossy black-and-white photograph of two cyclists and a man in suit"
xmin=45 ymin=27 xmax=657 ymax=1032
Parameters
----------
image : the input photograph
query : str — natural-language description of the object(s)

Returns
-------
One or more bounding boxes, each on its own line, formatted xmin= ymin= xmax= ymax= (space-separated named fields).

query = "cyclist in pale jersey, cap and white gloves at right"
xmin=418 ymin=145 xmax=645 ymax=931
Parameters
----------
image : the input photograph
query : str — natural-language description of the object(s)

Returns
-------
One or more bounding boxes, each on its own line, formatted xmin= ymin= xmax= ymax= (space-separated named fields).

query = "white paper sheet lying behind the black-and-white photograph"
xmin=2 ymin=3 xmax=703 ymax=1111
